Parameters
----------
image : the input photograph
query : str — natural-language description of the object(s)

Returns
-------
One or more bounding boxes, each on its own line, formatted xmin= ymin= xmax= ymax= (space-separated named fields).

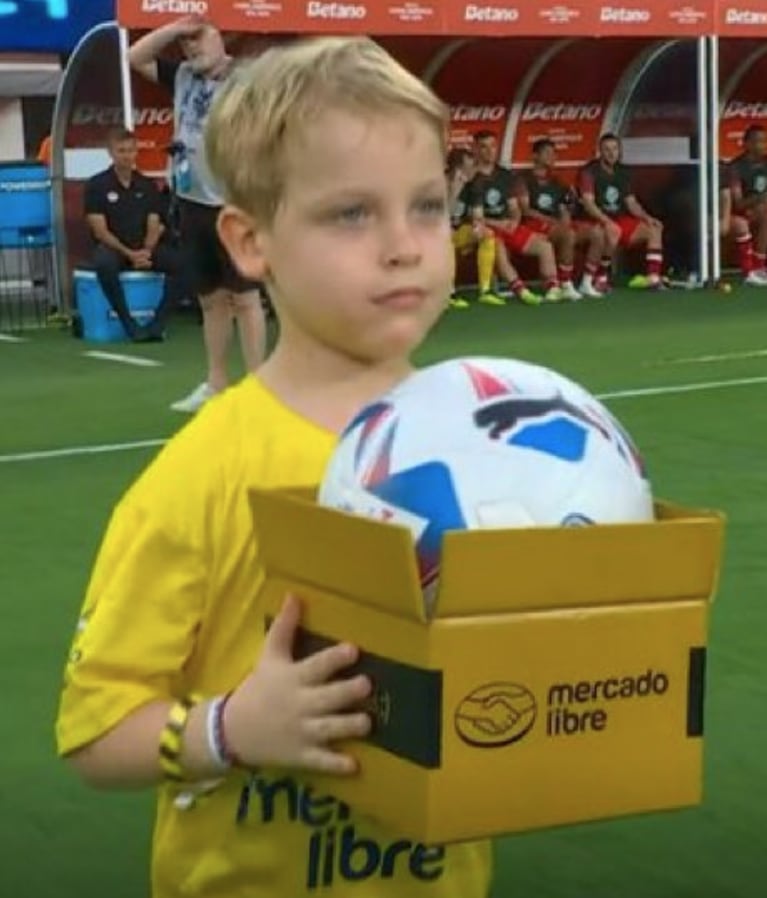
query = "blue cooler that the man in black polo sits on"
xmin=73 ymin=268 xmax=165 ymax=343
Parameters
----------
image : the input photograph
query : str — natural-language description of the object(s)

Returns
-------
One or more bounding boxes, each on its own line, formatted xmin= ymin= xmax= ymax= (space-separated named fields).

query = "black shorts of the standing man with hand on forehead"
xmin=178 ymin=199 xmax=260 ymax=296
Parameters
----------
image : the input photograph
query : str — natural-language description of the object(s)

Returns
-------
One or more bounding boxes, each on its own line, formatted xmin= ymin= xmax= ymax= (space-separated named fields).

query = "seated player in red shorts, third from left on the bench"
xmin=514 ymin=137 xmax=605 ymax=299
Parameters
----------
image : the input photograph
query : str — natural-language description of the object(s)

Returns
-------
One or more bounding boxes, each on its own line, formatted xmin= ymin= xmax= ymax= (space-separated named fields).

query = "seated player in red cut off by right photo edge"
xmin=729 ymin=125 xmax=767 ymax=287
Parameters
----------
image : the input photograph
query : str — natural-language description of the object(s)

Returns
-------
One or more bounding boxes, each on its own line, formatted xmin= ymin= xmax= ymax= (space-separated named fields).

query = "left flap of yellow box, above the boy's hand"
xmin=249 ymin=489 xmax=425 ymax=621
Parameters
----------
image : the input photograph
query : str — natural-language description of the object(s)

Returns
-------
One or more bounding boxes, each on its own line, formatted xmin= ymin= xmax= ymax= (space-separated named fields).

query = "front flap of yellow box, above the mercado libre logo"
xmin=435 ymin=504 xmax=724 ymax=617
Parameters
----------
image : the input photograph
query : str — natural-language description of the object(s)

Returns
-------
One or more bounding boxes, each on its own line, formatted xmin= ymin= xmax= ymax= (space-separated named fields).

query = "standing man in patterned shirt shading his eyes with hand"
xmin=128 ymin=16 xmax=265 ymax=413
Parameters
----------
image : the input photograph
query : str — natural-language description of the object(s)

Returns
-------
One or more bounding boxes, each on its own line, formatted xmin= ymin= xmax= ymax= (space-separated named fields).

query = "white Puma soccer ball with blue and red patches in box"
xmin=319 ymin=358 xmax=653 ymax=594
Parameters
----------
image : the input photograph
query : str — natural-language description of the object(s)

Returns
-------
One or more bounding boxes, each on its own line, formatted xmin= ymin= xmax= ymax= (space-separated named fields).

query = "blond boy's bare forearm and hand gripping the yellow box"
xmin=69 ymin=598 xmax=371 ymax=788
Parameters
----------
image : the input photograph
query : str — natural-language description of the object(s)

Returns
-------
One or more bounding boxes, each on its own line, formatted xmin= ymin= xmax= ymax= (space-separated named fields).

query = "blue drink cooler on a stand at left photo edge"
xmin=0 ymin=162 xmax=53 ymax=247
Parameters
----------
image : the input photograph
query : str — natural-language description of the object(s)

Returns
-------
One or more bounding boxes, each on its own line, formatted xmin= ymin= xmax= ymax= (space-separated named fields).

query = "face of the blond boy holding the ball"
xmin=248 ymin=109 xmax=454 ymax=363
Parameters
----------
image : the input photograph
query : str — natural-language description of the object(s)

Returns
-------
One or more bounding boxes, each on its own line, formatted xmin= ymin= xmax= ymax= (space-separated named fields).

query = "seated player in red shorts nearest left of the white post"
xmin=578 ymin=134 xmax=663 ymax=289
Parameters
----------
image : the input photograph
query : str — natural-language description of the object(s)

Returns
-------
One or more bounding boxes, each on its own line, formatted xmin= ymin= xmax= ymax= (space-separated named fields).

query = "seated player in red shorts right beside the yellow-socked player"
xmin=469 ymin=131 xmax=563 ymax=302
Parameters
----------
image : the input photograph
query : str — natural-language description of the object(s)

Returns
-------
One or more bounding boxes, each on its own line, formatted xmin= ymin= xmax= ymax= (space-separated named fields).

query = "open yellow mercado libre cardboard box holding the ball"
xmin=252 ymin=492 xmax=723 ymax=842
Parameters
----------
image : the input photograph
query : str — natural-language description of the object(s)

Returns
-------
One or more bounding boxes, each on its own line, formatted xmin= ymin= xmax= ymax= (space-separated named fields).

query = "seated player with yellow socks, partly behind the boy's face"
xmin=447 ymin=147 xmax=541 ymax=309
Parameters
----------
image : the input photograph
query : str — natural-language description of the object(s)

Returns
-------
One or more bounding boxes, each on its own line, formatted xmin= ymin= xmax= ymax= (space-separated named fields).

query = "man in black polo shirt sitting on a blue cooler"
xmin=85 ymin=128 xmax=178 ymax=342
